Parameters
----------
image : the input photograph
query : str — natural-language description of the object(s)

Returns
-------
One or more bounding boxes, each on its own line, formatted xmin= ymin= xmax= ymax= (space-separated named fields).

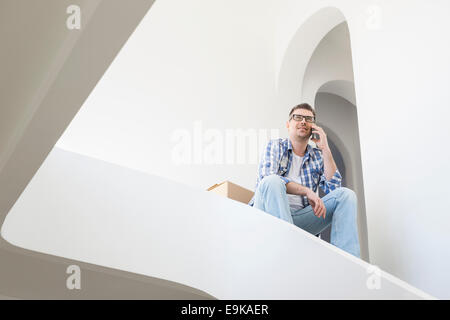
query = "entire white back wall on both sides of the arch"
xmin=52 ymin=0 xmax=450 ymax=298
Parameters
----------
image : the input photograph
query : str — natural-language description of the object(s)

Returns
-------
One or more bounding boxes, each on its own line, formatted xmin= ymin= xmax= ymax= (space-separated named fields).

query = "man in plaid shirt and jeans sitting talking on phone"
xmin=249 ymin=103 xmax=360 ymax=257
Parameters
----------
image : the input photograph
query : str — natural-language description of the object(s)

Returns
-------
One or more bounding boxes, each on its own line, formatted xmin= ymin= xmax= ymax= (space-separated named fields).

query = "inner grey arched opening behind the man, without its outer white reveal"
xmin=302 ymin=22 xmax=369 ymax=261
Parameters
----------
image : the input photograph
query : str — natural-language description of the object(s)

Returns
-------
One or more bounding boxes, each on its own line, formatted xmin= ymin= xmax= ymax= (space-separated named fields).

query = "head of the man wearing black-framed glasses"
xmin=286 ymin=103 xmax=316 ymax=140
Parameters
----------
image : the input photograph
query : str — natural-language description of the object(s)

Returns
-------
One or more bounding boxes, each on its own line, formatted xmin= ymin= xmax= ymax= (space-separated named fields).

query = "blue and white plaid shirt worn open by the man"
xmin=248 ymin=138 xmax=342 ymax=207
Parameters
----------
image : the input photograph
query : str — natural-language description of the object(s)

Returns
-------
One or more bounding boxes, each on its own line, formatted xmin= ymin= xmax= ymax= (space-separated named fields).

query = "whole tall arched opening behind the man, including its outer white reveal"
xmin=277 ymin=7 xmax=369 ymax=261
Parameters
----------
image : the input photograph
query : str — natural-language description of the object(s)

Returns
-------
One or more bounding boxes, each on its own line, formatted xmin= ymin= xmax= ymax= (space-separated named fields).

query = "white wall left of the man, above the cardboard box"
xmin=57 ymin=0 xmax=287 ymax=189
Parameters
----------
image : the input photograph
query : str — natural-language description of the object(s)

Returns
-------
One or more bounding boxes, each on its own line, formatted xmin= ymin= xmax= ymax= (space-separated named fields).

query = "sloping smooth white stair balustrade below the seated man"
xmin=1 ymin=149 xmax=430 ymax=299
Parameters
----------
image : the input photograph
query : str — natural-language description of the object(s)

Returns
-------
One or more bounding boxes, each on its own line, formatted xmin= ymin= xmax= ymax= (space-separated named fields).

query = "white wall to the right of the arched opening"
xmin=278 ymin=1 xmax=450 ymax=298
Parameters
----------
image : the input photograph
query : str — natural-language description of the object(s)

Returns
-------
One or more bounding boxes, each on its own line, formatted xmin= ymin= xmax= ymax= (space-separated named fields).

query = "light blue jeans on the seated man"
xmin=253 ymin=174 xmax=360 ymax=258
